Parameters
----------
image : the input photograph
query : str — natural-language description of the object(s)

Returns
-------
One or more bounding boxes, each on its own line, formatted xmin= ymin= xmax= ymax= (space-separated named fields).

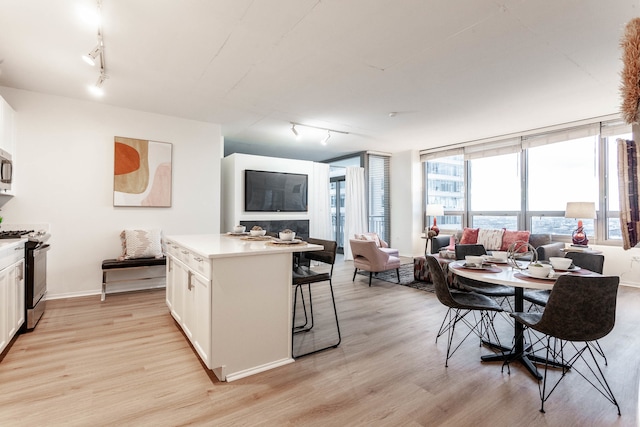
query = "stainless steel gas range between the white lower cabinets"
xmin=0 ymin=230 xmax=51 ymax=331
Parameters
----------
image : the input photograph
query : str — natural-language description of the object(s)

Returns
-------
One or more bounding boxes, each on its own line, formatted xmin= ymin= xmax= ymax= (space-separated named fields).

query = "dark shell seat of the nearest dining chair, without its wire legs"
xmin=534 ymin=275 xmax=620 ymax=341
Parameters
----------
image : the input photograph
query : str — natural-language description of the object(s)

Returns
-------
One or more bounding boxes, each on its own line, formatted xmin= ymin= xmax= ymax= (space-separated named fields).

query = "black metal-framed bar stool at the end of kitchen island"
xmin=291 ymin=238 xmax=342 ymax=358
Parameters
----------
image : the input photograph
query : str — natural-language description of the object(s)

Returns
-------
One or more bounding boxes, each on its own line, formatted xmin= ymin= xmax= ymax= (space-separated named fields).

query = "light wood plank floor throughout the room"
xmin=0 ymin=260 xmax=640 ymax=426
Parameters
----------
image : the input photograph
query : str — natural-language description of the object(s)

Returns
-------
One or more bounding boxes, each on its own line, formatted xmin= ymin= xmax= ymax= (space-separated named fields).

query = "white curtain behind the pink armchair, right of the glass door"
xmin=344 ymin=166 xmax=368 ymax=260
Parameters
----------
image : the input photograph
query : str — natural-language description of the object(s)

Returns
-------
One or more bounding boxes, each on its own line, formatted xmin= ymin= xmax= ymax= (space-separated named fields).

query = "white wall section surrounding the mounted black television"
xmin=222 ymin=153 xmax=315 ymax=234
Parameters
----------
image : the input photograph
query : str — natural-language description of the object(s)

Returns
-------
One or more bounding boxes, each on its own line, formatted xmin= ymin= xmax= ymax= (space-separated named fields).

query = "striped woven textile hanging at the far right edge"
xmin=617 ymin=139 xmax=640 ymax=250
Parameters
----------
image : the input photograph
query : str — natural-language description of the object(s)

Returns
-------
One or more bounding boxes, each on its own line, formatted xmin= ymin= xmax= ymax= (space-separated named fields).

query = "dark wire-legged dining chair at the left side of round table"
xmin=426 ymin=255 xmax=503 ymax=367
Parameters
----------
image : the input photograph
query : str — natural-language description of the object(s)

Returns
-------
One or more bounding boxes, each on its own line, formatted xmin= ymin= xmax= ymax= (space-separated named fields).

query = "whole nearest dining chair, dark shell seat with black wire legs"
xmin=503 ymin=275 xmax=620 ymax=415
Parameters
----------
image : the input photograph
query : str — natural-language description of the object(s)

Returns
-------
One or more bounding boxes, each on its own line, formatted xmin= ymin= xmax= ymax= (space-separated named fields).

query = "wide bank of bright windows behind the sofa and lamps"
xmin=421 ymin=121 xmax=631 ymax=244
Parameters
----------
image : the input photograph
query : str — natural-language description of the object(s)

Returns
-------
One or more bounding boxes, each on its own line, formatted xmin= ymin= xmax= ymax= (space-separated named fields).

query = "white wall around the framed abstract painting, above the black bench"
xmin=0 ymin=87 xmax=222 ymax=298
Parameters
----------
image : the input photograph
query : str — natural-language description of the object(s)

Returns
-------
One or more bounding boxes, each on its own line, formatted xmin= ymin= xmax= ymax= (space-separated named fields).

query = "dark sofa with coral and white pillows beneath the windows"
xmin=413 ymin=228 xmax=565 ymax=282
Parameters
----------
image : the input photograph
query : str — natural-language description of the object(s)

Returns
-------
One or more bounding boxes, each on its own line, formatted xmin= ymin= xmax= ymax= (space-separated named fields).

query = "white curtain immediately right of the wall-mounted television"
xmin=309 ymin=163 xmax=332 ymax=240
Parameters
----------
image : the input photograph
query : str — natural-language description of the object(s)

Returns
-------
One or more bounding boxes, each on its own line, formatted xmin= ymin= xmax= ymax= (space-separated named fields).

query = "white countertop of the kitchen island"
xmin=165 ymin=234 xmax=322 ymax=258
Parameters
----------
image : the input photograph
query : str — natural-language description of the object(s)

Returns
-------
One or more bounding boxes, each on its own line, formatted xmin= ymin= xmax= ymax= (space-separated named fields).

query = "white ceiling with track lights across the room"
xmin=0 ymin=0 xmax=640 ymax=160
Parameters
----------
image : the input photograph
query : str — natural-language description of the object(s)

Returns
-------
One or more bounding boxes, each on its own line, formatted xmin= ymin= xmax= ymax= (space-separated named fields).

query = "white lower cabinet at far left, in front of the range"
xmin=0 ymin=241 xmax=25 ymax=353
